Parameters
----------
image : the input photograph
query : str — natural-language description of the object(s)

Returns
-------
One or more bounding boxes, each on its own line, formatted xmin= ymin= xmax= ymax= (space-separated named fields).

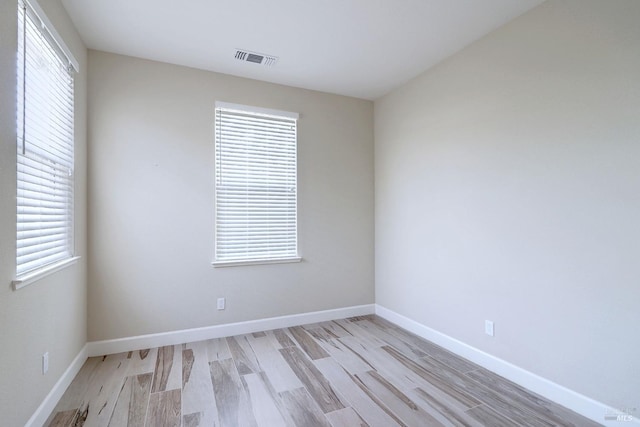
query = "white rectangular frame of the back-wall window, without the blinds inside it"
xmin=211 ymin=101 xmax=302 ymax=267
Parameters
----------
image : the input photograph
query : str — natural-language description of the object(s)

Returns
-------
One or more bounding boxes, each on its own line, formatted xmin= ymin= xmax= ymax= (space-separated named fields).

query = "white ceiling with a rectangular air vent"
xmin=62 ymin=0 xmax=543 ymax=99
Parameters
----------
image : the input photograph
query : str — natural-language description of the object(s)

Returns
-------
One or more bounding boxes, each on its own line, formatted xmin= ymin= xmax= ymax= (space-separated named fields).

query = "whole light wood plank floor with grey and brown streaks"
xmin=47 ymin=316 xmax=598 ymax=427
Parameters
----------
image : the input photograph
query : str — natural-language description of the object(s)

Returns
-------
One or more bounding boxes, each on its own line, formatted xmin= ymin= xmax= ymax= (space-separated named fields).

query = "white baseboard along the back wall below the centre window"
xmin=87 ymin=304 xmax=375 ymax=357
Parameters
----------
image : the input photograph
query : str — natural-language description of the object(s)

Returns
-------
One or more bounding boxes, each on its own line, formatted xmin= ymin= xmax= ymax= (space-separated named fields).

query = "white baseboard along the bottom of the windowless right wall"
xmin=375 ymin=304 xmax=640 ymax=427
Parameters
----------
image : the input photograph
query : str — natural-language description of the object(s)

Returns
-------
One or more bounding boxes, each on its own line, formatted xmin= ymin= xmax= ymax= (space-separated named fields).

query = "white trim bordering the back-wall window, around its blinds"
xmin=211 ymin=101 xmax=302 ymax=268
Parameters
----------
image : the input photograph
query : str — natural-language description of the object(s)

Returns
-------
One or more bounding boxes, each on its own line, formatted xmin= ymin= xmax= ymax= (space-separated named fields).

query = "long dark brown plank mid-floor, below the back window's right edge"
xmin=279 ymin=347 xmax=344 ymax=413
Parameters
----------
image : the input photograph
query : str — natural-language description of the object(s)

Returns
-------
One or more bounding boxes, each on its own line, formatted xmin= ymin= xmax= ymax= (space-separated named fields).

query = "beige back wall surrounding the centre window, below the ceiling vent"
xmin=88 ymin=51 xmax=374 ymax=341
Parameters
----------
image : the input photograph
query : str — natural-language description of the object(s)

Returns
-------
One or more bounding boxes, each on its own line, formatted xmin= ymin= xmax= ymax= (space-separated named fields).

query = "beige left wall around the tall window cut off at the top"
xmin=0 ymin=0 xmax=87 ymax=426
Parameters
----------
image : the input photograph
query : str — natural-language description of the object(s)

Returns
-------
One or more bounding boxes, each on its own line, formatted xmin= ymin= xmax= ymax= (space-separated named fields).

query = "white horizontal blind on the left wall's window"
xmin=16 ymin=2 xmax=74 ymax=277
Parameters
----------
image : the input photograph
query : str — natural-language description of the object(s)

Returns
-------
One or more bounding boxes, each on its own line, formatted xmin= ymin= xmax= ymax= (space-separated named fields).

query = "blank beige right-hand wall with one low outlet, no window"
xmin=375 ymin=0 xmax=640 ymax=408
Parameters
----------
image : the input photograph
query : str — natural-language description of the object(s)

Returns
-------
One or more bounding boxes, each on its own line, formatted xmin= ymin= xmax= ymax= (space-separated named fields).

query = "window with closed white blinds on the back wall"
xmin=213 ymin=102 xmax=300 ymax=266
